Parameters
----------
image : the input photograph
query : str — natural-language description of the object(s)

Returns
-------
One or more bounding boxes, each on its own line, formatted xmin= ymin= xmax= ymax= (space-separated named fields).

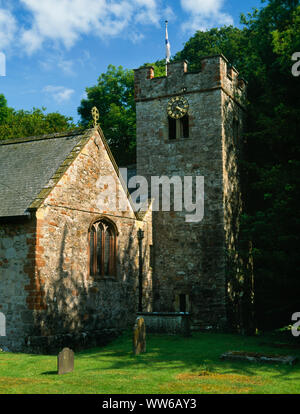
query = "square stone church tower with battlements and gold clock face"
xmin=135 ymin=55 xmax=246 ymax=329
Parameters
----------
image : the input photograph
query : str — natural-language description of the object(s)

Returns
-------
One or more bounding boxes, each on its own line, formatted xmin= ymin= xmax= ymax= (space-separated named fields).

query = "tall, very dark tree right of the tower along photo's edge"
xmin=237 ymin=0 xmax=300 ymax=327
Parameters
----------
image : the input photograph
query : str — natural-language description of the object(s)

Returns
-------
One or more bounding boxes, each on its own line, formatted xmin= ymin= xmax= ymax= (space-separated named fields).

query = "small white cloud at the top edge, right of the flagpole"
xmin=180 ymin=0 xmax=233 ymax=32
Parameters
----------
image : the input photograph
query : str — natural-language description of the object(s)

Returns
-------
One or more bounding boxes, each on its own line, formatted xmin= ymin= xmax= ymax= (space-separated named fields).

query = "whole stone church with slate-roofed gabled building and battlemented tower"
xmin=0 ymin=55 xmax=246 ymax=351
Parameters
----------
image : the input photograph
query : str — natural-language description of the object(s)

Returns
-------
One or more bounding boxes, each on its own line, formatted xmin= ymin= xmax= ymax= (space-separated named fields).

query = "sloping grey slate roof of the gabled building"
xmin=0 ymin=129 xmax=93 ymax=217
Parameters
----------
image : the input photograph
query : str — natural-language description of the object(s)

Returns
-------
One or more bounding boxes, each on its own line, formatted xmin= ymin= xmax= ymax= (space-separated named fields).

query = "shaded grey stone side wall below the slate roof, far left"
xmin=0 ymin=218 xmax=35 ymax=349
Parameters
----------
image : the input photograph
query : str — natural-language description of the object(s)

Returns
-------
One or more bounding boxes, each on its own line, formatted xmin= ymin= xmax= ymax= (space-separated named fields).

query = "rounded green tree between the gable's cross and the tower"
xmin=78 ymin=65 xmax=136 ymax=165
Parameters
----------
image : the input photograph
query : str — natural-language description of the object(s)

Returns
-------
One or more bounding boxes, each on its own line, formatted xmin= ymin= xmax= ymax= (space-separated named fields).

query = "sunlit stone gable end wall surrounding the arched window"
xmin=28 ymin=131 xmax=152 ymax=350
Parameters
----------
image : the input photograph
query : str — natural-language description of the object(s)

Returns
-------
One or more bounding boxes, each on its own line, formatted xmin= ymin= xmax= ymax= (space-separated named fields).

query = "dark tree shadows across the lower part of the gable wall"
xmin=26 ymin=218 xmax=146 ymax=353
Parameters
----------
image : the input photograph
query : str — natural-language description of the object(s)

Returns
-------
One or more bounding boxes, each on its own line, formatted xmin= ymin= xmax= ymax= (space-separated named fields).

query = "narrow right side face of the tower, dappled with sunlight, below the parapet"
xmin=222 ymin=93 xmax=254 ymax=332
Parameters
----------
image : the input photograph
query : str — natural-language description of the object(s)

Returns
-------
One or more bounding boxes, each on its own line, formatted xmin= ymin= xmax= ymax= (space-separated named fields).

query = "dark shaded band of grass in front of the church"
xmin=72 ymin=333 xmax=300 ymax=381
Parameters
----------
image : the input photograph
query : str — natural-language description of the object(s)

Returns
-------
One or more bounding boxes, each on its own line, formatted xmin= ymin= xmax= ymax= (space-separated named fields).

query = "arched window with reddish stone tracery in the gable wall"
xmin=89 ymin=220 xmax=116 ymax=277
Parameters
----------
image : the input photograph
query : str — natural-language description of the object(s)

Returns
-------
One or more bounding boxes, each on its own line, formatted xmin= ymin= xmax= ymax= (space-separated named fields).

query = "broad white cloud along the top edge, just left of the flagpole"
xmin=20 ymin=0 xmax=171 ymax=53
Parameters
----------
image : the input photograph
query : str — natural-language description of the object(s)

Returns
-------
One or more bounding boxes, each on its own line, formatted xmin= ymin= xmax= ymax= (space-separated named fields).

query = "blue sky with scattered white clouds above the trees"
xmin=0 ymin=0 xmax=262 ymax=121
